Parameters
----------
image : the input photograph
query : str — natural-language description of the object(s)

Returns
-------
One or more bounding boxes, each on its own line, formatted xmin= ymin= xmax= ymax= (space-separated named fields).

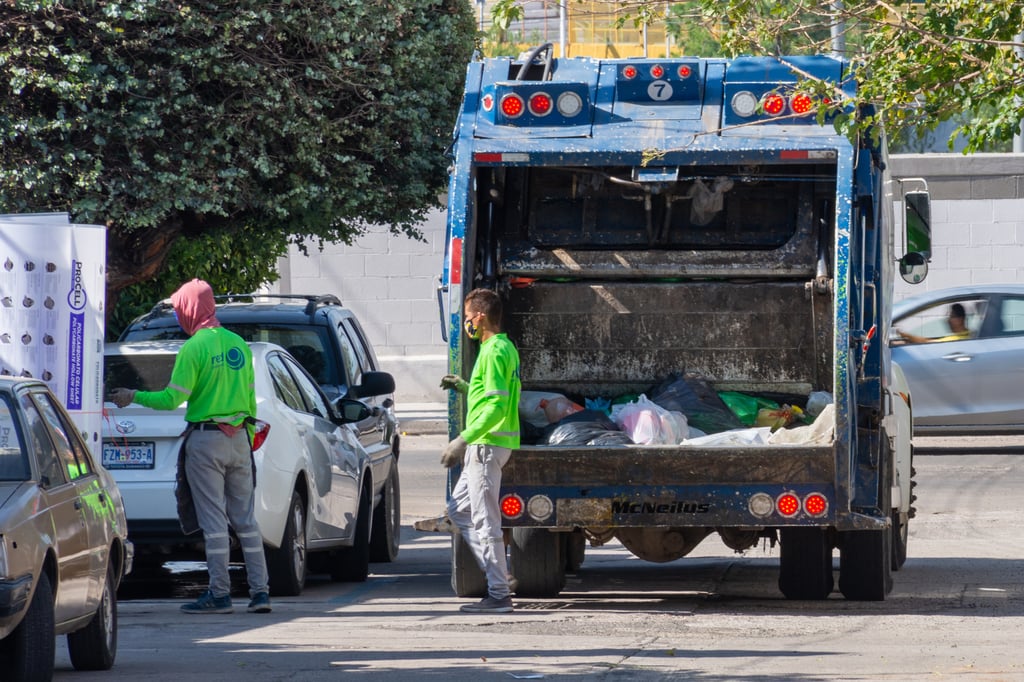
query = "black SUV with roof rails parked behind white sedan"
xmin=118 ymin=294 xmax=401 ymax=561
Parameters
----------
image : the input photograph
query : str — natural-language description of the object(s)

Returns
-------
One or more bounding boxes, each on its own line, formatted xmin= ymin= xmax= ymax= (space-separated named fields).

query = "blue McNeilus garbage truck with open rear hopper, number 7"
xmin=438 ymin=45 xmax=931 ymax=600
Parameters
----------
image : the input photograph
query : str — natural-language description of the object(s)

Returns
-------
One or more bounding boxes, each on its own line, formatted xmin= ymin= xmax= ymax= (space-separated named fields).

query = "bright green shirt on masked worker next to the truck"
xmin=461 ymin=334 xmax=522 ymax=449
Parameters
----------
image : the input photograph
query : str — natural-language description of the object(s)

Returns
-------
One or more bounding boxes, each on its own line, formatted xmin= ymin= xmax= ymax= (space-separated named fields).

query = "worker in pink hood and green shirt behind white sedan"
xmin=110 ymin=280 xmax=270 ymax=613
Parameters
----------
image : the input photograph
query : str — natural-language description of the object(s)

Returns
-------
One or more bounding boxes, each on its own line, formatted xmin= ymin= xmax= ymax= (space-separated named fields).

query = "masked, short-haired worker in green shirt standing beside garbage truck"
xmin=441 ymin=289 xmax=521 ymax=613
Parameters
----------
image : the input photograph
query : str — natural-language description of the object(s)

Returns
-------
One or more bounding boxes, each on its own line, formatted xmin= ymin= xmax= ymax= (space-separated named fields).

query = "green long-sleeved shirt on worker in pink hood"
xmin=135 ymin=327 xmax=256 ymax=426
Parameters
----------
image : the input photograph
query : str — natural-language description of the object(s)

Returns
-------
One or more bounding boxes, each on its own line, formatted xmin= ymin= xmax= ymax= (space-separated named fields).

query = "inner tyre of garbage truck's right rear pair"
xmin=778 ymin=527 xmax=835 ymax=599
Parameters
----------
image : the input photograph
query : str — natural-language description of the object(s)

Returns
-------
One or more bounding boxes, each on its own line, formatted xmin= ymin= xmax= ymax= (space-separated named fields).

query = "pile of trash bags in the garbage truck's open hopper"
xmin=519 ymin=373 xmax=836 ymax=446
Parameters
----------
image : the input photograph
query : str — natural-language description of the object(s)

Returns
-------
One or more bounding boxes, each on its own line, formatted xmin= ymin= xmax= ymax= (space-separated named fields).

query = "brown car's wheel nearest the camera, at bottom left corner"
xmin=0 ymin=571 xmax=56 ymax=682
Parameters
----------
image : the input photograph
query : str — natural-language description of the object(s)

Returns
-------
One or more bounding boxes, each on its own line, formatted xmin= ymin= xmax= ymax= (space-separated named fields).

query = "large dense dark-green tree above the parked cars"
xmin=0 ymin=0 xmax=475 ymax=327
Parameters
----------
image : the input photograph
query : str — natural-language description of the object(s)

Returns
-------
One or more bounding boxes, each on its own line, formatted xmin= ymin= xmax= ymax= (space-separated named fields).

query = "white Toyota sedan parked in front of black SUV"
xmin=102 ymin=341 xmax=394 ymax=596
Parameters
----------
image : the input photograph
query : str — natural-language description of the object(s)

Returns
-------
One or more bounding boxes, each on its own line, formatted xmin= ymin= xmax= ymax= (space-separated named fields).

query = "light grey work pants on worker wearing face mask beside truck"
xmin=447 ymin=445 xmax=512 ymax=599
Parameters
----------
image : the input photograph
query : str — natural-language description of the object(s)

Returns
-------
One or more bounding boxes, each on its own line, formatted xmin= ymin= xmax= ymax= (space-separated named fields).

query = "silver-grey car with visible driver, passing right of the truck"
xmin=890 ymin=284 xmax=1024 ymax=435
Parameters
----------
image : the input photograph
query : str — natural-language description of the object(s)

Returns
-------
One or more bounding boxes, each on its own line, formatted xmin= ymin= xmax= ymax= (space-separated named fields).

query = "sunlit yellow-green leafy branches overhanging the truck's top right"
xmin=495 ymin=0 xmax=1024 ymax=152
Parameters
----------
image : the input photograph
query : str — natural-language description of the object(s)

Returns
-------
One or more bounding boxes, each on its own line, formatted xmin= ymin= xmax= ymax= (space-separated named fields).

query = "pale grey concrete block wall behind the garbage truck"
xmin=274 ymin=154 xmax=1024 ymax=403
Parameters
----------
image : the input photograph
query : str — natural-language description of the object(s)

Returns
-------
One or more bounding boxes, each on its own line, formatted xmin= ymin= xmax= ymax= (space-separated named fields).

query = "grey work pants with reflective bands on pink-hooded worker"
xmin=185 ymin=429 xmax=269 ymax=597
